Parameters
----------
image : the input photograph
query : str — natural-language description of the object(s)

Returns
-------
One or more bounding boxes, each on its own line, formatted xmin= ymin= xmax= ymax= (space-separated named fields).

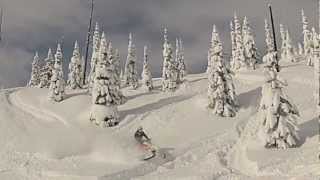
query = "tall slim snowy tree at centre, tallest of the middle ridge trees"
xmin=162 ymin=28 xmax=178 ymax=91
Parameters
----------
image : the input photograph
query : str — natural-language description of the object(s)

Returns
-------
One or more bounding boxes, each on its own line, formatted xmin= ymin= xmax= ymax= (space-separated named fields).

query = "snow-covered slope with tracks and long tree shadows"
xmin=0 ymin=63 xmax=320 ymax=180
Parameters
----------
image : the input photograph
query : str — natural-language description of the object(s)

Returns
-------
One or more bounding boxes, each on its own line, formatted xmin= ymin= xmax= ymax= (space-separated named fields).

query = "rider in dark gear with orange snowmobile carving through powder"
xmin=134 ymin=127 xmax=157 ymax=160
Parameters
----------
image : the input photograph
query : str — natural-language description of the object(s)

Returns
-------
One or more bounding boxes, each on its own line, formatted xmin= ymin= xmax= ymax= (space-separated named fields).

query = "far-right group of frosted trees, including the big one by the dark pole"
xmin=260 ymin=9 xmax=320 ymax=149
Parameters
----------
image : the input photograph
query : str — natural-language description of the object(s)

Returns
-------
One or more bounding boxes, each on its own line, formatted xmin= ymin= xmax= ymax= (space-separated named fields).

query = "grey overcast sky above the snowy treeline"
xmin=0 ymin=0 xmax=318 ymax=87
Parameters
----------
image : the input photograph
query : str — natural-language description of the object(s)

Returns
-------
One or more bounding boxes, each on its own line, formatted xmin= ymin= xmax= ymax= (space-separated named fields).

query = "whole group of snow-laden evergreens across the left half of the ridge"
xmin=28 ymin=24 xmax=186 ymax=127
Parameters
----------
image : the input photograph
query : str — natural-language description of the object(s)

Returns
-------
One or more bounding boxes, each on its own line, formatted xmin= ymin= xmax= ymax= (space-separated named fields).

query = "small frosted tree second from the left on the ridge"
xmin=39 ymin=48 xmax=55 ymax=88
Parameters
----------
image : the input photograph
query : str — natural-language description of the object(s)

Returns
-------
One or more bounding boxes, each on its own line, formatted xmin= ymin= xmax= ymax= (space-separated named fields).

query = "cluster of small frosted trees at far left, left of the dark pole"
xmin=28 ymin=42 xmax=84 ymax=102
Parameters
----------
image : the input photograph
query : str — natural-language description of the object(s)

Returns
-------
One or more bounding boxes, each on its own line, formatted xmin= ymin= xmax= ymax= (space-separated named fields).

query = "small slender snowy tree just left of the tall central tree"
xmin=141 ymin=46 xmax=153 ymax=91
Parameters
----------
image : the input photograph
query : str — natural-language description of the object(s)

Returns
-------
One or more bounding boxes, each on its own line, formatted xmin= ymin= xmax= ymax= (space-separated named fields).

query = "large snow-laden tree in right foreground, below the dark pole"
xmin=259 ymin=65 xmax=299 ymax=149
